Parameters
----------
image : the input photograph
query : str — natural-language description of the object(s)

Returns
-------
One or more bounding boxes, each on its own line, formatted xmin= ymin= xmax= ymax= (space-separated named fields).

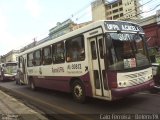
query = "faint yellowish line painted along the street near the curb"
xmin=11 ymin=91 xmax=92 ymax=120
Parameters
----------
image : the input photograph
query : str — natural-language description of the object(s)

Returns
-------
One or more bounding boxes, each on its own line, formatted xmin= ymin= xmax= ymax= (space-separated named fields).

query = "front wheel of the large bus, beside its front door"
xmin=72 ymin=80 xmax=86 ymax=103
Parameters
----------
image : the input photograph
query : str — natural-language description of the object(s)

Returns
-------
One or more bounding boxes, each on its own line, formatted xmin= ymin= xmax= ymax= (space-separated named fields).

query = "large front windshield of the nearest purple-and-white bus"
xmin=106 ymin=32 xmax=150 ymax=70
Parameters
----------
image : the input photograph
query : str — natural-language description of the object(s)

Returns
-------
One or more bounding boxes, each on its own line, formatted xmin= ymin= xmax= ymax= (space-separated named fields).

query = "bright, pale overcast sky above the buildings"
xmin=0 ymin=0 xmax=160 ymax=55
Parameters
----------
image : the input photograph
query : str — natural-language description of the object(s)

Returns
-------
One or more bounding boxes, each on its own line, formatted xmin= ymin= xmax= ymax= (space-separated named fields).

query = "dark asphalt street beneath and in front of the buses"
xmin=0 ymin=81 xmax=160 ymax=119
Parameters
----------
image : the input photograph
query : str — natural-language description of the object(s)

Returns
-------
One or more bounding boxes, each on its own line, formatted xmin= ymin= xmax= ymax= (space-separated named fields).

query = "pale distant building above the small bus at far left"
xmin=0 ymin=50 xmax=19 ymax=63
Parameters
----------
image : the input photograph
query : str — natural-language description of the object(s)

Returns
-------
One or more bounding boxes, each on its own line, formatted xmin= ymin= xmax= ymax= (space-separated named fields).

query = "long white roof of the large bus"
xmin=19 ymin=20 xmax=139 ymax=56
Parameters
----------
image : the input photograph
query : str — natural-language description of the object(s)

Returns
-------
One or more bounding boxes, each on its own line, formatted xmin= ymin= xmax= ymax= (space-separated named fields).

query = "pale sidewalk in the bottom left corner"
xmin=0 ymin=90 xmax=48 ymax=120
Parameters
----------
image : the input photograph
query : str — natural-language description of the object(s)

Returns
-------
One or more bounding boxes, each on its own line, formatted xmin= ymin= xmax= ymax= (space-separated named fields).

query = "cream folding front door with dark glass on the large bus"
xmin=89 ymin=35 xmax=110 ymax=99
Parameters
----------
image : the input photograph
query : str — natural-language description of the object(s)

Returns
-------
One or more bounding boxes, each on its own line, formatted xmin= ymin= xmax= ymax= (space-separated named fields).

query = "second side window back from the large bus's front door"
xmin=52 ymin=41 xmax=65 ymax=63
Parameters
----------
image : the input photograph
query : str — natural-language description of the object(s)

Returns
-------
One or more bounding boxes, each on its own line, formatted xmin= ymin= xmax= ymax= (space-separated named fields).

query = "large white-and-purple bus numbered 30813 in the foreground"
xmin=18 ymin=20 xmax=154 ymax=102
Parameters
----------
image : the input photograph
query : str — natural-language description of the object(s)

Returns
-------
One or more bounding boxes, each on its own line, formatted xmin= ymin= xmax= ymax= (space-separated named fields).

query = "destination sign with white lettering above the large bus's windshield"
xmin=105 ymin=21 xmax=143 ymax=32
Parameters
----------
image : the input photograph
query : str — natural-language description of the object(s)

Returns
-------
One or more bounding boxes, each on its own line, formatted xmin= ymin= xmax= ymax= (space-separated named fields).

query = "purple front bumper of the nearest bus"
xmin=111 ymin=80 xmax=155 ymax=100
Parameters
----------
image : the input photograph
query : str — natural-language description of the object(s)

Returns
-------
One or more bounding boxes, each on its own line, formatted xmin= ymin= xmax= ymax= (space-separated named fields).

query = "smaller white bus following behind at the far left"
xmin=0 ymin=62 xmax=18 ymax=81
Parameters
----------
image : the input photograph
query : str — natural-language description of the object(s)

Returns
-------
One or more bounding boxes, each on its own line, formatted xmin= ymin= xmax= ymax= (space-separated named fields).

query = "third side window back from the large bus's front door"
xmin=43 ymin=46 xmax=52 ymax=65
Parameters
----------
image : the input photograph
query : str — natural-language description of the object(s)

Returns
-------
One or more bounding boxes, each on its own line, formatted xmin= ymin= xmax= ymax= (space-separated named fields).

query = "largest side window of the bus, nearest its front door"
xmin=66 ymin=36 xmax=85 ymax=62
